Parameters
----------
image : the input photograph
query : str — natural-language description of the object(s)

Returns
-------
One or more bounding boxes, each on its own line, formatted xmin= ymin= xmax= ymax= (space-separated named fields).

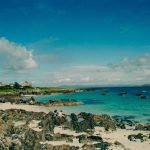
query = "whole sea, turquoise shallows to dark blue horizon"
xmin=35 ymin=86 xmax=150 ymax=123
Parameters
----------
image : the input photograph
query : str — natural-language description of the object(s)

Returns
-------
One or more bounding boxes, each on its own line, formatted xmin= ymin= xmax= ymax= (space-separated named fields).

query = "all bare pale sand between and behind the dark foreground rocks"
xmin=0 ymin=103 xmax=150 ymax=150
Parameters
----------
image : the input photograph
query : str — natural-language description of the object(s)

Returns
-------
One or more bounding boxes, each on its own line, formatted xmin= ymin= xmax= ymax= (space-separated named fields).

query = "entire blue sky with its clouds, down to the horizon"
xmin=0 ymin=0 xmax=150 ymax=86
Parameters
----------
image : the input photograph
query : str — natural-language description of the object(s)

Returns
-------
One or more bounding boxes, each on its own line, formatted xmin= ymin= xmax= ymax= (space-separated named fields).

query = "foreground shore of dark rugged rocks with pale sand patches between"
xmin=0 ymin=109 xmax=150 ymax=150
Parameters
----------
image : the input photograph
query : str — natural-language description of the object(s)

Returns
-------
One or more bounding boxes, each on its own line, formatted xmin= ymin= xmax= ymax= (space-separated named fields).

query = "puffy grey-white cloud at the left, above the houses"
xmin=0 ymin=38 xmax=37 ymax=73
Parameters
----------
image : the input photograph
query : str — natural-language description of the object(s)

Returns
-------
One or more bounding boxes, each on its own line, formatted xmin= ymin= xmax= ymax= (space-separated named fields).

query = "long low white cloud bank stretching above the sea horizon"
xmin=42 ymin=54 xmax=150 ymax=85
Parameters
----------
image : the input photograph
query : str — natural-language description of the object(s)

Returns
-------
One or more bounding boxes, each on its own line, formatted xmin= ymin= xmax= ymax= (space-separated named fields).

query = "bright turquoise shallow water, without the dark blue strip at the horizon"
xmin=35 ymin=90 xmax=150 ymax=122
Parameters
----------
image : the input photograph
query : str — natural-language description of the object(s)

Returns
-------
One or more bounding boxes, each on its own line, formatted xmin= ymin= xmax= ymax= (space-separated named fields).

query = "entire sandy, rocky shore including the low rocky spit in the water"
xmin=0 ymin=91 xmax=150 ymax=150
